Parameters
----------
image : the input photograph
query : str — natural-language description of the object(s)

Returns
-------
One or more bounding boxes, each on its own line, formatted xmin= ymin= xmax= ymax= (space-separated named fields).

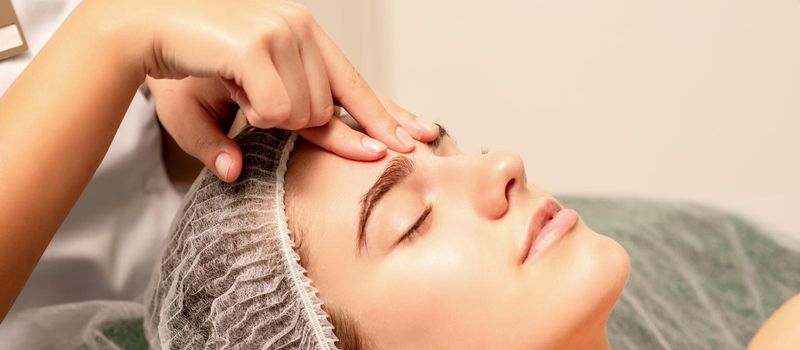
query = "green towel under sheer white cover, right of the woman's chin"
xmin=560 ymin=197 xmax=800 ymax=350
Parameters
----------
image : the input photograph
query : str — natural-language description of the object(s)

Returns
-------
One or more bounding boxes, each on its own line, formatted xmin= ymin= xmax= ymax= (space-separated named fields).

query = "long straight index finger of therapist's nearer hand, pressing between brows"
xmin=313 ymin=24 xmax=414 ymax=152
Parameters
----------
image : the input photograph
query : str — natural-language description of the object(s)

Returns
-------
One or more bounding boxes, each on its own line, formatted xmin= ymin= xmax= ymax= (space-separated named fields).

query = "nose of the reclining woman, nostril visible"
xmin=472 ymin=152 xmax=526 ymax=219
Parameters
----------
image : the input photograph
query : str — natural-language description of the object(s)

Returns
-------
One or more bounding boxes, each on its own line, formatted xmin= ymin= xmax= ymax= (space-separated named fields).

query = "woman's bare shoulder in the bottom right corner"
xmin=747 ymin=294 xmax=800 ymax=350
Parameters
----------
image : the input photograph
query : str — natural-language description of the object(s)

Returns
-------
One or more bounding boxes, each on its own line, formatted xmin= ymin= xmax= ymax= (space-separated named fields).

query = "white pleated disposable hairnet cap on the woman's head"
xmin=145 ymin=128 xmax=337 ymax=349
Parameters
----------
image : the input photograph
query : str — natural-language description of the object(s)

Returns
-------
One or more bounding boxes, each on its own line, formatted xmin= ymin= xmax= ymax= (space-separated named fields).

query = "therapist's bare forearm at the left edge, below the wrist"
xmin=0 ymin=4 xmax=144 ymax=320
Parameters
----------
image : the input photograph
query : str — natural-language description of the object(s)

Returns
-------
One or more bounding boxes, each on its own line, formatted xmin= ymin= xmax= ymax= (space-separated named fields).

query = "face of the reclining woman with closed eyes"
xmin=286 ymin=129 xmax=629 ymax=349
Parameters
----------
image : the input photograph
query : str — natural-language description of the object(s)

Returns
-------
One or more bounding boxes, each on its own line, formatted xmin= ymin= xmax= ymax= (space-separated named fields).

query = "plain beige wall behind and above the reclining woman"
xmin=307 ymin=0 xmax=800 ymax=243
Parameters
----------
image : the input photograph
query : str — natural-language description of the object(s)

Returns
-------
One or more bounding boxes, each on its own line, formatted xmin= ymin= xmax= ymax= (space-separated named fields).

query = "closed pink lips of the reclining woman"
xmin=521 ymin=198 xmax=579 ymax=263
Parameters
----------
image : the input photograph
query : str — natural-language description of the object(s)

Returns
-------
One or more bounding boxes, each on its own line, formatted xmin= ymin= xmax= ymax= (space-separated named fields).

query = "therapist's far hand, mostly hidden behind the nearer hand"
xmin=146 ymin=77 xmax=438 ymax=182
